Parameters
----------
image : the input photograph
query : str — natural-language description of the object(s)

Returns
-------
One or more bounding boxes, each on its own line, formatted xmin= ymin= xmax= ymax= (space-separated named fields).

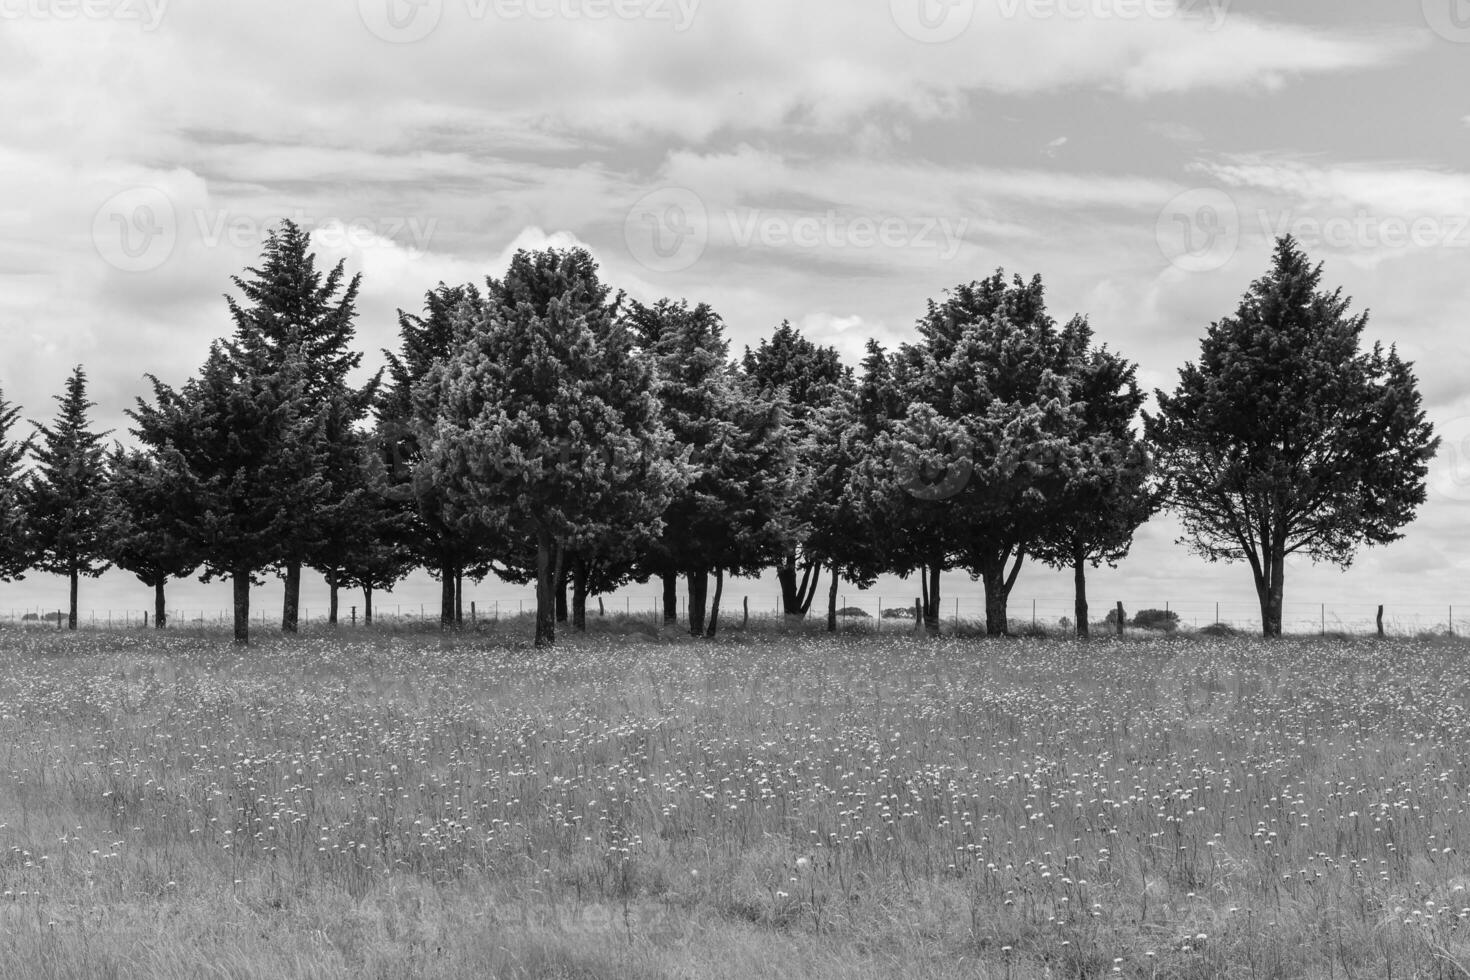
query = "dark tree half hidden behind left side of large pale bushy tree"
xmin=378 ymin=282 xmax=487 ymax=626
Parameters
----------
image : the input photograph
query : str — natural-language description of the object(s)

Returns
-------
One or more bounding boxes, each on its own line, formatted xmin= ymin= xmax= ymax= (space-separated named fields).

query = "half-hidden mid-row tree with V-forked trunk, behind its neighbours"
xmin=742 ymin=320 xmax=853 ymax=619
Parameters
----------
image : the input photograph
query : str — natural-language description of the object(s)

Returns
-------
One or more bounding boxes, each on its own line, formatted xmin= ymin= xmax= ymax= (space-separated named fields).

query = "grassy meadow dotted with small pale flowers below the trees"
xmin=0 ymin=629 xmax=1470 ymax=980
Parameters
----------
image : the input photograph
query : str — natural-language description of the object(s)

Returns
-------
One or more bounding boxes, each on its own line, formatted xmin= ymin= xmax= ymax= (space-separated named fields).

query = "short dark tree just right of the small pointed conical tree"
xmin=104 ymin=445 xmax=198 ymax=629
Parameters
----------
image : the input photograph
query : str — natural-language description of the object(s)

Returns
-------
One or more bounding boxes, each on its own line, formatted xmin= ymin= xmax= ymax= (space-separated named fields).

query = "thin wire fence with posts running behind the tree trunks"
xmin=0 ymin=592 xmax=1470 ymax=636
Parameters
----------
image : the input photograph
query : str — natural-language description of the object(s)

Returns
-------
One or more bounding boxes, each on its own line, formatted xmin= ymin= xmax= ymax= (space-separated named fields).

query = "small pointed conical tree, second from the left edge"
xmin=25 ymin=364 xmax=109 ymax=629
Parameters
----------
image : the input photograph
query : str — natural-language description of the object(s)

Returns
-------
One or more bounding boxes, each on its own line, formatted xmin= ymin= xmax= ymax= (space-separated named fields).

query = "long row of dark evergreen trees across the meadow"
xmin=0 ymin=223 xmax=1438 ymax=644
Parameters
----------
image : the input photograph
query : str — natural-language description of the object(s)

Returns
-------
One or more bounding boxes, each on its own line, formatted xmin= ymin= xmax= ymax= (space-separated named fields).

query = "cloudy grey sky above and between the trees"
xmin=0 ymin=0 xmax=1470 ymax=620
